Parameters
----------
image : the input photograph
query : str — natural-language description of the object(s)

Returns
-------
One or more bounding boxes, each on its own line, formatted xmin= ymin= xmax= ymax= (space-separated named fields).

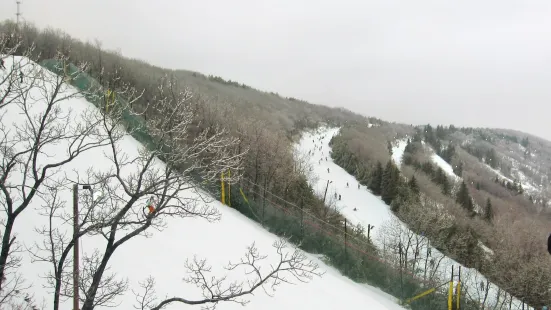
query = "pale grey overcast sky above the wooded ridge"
xmin=4 ymin=0 xmax=551 ymax=139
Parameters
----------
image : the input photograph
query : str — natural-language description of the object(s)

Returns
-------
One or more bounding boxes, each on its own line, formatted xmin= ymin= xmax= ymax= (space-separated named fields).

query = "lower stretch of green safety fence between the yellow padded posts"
xmin=223 ymin=179 xmax=480 ymax=310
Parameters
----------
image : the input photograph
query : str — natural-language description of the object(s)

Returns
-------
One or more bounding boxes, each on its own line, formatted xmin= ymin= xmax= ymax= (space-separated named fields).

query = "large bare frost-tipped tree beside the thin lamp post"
xmin=17 ymin=60 xmax=320 ymax=310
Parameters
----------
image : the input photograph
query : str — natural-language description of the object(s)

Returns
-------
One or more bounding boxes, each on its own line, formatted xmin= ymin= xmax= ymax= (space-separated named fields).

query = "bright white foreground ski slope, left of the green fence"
xmin=0 ymin=57 xmax=402 ymax=310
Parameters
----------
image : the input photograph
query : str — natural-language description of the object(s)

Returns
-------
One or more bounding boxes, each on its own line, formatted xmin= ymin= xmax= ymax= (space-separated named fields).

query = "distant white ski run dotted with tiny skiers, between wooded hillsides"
xmin=296 ymin=128 xmax=527 ymax=309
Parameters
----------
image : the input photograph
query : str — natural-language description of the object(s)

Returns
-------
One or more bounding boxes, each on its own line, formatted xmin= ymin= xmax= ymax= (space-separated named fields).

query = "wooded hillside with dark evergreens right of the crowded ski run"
xmin=332 ymin=125 xmax=551 ymax=304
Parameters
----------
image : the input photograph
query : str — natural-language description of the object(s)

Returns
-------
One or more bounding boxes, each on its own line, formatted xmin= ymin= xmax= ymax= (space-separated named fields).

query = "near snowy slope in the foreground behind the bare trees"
xmin=0 ymin=57 xmax=401 ymax=310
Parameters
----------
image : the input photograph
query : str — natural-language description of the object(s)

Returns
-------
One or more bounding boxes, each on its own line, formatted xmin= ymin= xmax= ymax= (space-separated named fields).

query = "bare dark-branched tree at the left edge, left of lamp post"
xmin=0 ymin=36 xmax=118 ymax=308
